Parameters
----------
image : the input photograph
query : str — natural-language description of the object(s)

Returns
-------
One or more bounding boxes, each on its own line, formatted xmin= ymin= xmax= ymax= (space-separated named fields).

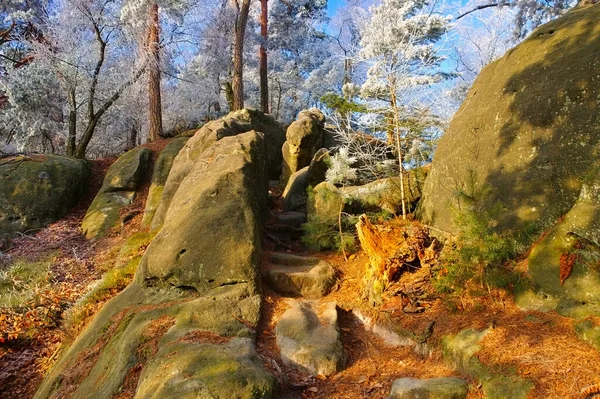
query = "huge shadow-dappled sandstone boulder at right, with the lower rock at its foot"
xmin=418 ymin=5 xmax=600 ymax=316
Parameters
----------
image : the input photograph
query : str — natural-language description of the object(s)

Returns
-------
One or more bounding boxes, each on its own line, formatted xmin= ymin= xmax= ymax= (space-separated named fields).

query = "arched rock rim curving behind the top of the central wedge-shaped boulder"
xmin=152 ymin=109 xmax=285 ymax=229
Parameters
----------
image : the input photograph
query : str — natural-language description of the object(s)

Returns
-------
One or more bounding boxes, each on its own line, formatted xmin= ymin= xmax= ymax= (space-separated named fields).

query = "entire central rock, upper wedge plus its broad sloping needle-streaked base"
xmin=35 ymin=132 xmax=276 ymax=399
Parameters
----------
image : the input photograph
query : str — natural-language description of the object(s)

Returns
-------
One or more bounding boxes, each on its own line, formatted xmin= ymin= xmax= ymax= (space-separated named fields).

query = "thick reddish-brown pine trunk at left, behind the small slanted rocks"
xmin=148 ymin=3 xmax=163 ymax=141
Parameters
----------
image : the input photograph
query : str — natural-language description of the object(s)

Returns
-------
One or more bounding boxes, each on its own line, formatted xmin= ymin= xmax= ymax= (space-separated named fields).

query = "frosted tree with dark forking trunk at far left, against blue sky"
xmin=0 ymin=0 xmax=143 ymax=158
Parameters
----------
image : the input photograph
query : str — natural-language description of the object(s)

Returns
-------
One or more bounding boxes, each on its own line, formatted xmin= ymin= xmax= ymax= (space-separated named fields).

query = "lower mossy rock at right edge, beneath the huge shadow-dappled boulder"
xmin=516 ymin=167 xmax=600 ymax=317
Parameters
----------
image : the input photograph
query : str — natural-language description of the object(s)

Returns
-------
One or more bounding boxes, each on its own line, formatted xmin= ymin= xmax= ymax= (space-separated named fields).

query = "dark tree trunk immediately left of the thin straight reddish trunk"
xmin=231 ymin=0 xmax=251 ymax=111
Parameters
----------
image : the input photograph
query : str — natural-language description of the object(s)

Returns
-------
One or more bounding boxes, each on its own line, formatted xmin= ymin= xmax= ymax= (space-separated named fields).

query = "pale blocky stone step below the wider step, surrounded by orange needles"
xmin=275 ymin=300 xmax=345 ymax=376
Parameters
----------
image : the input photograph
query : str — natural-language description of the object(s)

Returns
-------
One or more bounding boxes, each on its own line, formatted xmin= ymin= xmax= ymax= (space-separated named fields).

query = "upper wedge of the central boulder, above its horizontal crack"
xmin=137 ymin=132 xmax=268 ymax=292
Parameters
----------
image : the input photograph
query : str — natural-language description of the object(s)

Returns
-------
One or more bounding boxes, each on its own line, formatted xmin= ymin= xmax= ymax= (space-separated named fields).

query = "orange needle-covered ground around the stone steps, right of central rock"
xmin=258 ymin=188 xmax=600 ymax=399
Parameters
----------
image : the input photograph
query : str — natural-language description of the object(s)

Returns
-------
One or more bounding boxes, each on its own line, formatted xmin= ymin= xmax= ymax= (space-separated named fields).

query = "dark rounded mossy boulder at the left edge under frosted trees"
xmin=0 ymin=155 xmax=90 ymax=236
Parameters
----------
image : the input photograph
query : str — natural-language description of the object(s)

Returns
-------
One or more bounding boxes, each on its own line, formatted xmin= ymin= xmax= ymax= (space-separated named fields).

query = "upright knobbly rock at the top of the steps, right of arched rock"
xmin=281 ymin=108 xmax=325 ymax=184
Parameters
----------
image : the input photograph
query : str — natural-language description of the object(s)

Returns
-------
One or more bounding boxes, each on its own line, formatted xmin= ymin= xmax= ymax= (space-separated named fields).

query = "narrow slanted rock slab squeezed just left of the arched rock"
xmin=142 ymin=136 xmax=189 ymax=227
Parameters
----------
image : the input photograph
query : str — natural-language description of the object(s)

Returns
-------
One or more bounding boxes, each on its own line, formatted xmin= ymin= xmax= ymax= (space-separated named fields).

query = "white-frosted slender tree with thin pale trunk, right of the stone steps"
xmin=360 ymin=0 xmax=449 ymax=217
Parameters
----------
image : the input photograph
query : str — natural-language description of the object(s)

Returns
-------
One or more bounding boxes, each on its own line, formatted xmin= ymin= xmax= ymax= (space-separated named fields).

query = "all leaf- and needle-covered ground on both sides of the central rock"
xmin=0 ymin=158 xmax=600 ymax=399
